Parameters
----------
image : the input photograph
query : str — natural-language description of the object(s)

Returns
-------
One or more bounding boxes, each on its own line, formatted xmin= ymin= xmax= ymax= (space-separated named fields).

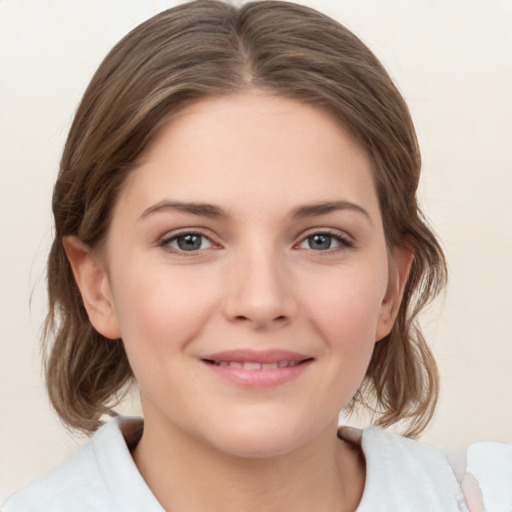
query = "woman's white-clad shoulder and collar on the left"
xmin=2 ymin=418 xmax=162 ymax=512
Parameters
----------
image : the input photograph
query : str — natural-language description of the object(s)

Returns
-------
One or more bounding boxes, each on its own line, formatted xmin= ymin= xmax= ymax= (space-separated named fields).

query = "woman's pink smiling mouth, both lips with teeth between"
xmin=200 ymin=349 xmax=314 ymax=388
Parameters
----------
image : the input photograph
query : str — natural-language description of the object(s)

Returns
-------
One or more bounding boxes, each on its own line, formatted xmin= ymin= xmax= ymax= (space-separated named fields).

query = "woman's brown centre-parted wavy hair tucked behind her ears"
xmin=43 ymin=0 xmax=446 ymax=435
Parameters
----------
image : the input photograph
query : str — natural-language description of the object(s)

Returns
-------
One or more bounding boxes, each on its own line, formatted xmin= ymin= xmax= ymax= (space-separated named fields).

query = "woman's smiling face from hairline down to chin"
xmin=74 ymin=91 xmax=406 ymax=456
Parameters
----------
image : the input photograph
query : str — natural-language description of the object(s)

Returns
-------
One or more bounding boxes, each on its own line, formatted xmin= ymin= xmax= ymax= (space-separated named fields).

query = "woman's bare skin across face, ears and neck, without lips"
xmin=65 ymin=91 xmax=410 ymax=511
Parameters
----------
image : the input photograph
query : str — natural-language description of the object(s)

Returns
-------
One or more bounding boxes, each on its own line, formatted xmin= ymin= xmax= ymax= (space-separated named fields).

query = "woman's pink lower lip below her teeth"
xmin=204 ymin=360 xmax=313 ymax=389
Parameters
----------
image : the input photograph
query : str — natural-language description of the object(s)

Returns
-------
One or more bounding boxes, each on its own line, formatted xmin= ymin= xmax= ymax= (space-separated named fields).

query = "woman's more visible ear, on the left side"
xmin=62 ymin=236 xmax=121 ymax=339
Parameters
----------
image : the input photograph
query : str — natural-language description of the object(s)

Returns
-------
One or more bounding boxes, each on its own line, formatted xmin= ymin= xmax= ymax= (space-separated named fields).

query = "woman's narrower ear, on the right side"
xmin=375 ymin=249 xmax=413 ymax=341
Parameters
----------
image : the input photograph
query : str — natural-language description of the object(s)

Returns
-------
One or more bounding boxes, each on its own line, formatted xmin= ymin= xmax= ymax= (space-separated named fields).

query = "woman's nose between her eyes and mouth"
xmin=224 ymin=246 xmax=298 ymax=330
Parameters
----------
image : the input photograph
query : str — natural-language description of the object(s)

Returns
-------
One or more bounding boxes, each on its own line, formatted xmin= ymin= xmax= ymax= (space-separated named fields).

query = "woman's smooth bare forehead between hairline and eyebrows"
xmin=117 ymin=91 xmax=378 ymax=218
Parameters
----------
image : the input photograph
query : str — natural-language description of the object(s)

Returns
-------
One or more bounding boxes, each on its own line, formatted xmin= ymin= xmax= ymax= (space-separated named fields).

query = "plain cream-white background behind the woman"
xmin=0 ymin=0 xmax=512 ymax=502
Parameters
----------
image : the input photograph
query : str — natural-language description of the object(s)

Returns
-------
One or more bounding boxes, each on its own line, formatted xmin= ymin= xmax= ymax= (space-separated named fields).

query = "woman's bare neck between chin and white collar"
xmin=133 ymin=414 xmax=364 ymax=512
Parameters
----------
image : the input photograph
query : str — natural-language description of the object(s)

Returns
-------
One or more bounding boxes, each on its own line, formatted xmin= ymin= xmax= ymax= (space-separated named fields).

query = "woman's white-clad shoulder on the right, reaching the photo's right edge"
xmin=340 ymin=427 xmax=512 ymax=512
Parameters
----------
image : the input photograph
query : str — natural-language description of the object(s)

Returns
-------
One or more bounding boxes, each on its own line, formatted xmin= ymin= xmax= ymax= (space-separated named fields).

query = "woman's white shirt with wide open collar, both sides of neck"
xmin=2 ymin=417 xmax=512 ymax=512
